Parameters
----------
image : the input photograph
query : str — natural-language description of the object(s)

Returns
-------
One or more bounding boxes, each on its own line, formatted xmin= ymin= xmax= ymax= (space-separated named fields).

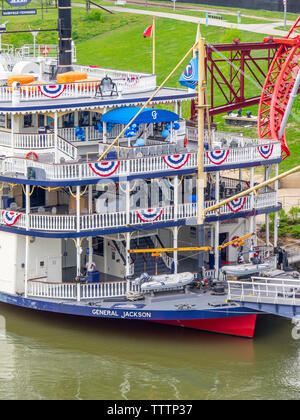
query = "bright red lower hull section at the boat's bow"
xmin=151 ymin=315 xmax=256 ymax=338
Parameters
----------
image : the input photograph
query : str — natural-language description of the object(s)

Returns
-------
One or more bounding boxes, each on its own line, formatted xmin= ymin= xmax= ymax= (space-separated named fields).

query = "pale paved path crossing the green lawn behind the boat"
xmin=109 ymin=6 xmax=286 ymax=37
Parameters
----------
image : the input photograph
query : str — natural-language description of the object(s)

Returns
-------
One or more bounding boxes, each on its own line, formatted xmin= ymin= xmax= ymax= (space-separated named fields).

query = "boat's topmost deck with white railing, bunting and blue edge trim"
xmin=0 ymin=61 xmax=195 ymax=114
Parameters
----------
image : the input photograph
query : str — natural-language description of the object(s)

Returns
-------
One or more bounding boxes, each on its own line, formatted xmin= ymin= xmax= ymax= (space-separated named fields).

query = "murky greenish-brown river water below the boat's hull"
xmin=0 ymin=304 xmax=300 ymax=400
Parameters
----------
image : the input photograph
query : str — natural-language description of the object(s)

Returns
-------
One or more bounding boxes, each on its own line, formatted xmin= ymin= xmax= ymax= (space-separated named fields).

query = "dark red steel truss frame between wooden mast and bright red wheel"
xmin=191 ymin=37 xmax=279 ymax=122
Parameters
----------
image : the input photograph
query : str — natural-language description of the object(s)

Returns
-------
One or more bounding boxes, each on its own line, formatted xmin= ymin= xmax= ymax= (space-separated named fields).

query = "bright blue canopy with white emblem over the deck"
xmin=101 ymin=107 xmax=180 ymax=125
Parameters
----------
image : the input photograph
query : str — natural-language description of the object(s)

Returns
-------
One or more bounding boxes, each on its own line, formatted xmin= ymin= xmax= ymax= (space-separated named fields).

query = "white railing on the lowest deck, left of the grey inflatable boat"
xmin=27 ymin=280 xmax=139 ymax=302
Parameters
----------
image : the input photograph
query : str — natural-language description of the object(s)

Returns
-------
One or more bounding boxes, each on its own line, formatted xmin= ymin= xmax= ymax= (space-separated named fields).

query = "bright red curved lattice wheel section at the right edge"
xmin=258 ymin=16 xmax=300 ymax=159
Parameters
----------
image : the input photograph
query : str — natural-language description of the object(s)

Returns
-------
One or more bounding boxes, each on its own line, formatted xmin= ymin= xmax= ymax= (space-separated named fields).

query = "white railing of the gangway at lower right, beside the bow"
xmin=228 ymin=277 xmax=300 ymax=305
